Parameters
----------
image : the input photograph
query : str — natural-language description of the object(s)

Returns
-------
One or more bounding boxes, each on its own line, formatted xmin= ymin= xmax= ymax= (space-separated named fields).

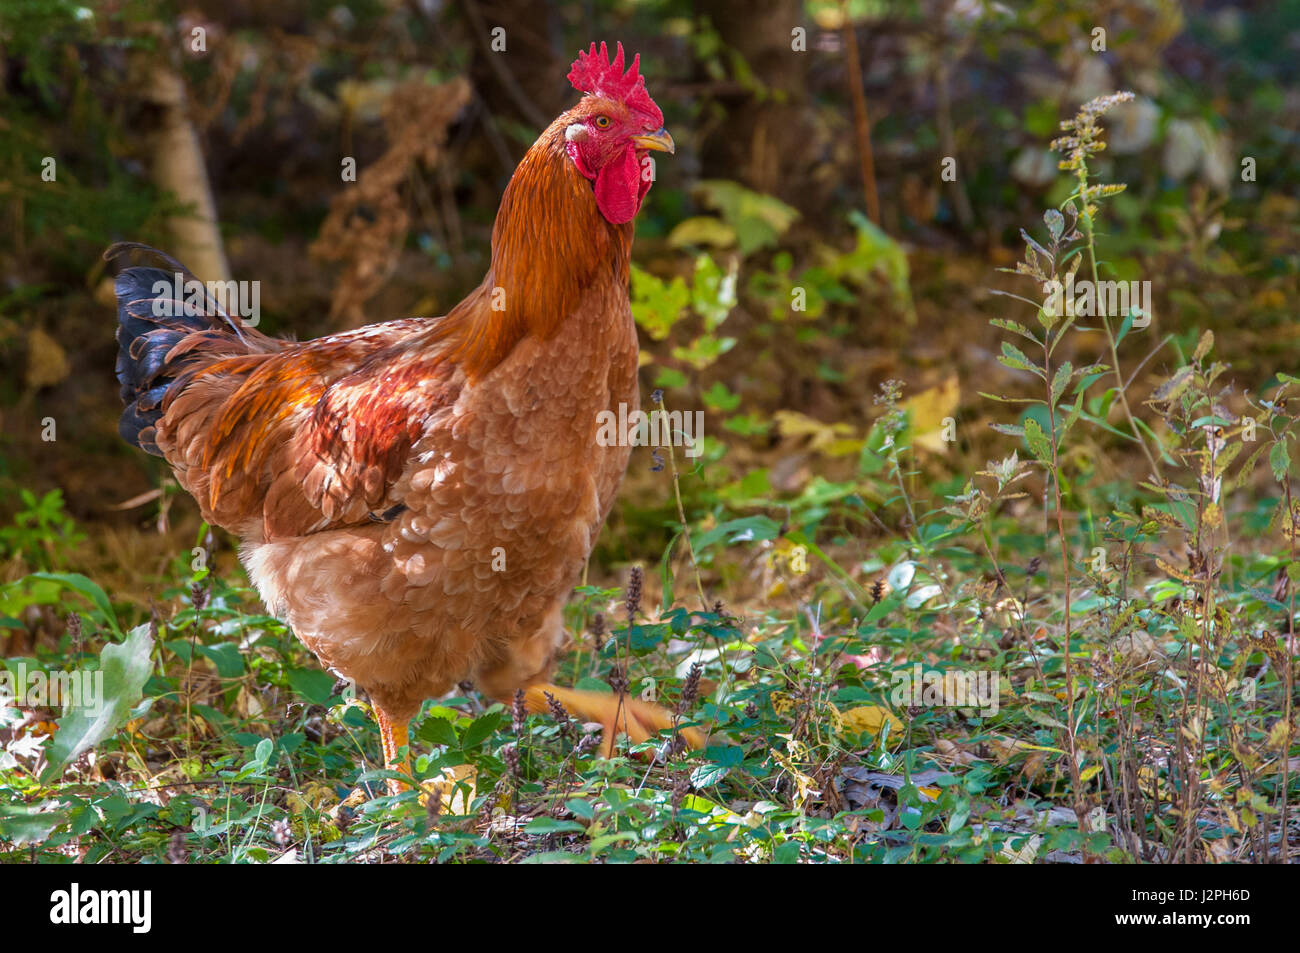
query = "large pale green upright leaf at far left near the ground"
xmin=42 ymin=616 xmax=153 ymax=781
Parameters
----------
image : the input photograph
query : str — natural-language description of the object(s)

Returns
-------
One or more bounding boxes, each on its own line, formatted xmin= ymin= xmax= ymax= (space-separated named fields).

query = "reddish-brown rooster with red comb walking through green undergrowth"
xmin=107 ymin=43 xmax=702 ymax=793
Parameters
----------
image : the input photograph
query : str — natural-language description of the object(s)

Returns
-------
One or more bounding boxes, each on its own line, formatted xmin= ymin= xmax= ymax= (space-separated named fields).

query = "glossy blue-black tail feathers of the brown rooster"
xmin=104 ymin=242 xmax=243 ymax=456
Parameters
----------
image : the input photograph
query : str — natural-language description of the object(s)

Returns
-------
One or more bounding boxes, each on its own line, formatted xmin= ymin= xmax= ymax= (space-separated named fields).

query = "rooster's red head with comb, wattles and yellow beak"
xmin=564 ymin=43 xmax=675 ymax=225
